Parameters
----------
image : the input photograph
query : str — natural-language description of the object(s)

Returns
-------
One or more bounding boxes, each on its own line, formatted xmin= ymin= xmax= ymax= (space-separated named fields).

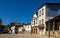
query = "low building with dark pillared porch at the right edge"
xmin=46 ymin=15 xmax=60 ymax=37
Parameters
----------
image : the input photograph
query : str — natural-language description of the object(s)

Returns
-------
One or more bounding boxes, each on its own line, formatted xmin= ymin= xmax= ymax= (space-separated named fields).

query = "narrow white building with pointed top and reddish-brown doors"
xmin=31 ymin=10 xmax=39 ymax=34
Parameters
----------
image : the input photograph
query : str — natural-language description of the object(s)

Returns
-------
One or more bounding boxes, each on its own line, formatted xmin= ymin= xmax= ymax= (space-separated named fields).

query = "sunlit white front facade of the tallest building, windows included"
xmin=38 ymin=5 xmax=46 ymax=34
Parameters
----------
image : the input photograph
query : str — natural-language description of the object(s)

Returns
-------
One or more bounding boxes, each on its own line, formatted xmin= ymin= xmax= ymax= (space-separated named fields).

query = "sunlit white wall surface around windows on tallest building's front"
xmin=38 ymin=5 xmax=46 ymax=34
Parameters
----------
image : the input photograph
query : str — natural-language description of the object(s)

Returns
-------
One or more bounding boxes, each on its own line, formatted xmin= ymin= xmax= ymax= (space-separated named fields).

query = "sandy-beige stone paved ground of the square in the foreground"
xmin=0 ymin=34 xmax=59 ymax=38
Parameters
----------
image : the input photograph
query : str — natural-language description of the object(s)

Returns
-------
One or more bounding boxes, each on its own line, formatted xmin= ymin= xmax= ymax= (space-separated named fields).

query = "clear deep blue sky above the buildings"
xmin=0 ymin=0 xmax=60 ymax=24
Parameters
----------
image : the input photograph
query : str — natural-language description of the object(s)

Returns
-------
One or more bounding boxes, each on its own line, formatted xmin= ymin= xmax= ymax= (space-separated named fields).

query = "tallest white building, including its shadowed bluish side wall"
xmin=38 ymin=3 xmax=60 ymax=34
